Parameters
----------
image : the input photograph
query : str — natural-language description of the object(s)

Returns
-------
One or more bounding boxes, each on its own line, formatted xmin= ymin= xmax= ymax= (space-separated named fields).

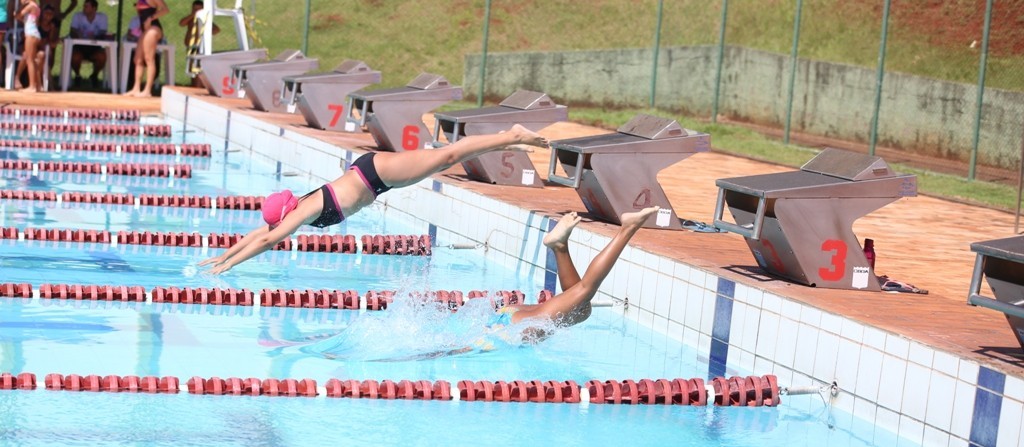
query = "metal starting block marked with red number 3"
xmin=714 ymin=148 xmax=918 ymax=292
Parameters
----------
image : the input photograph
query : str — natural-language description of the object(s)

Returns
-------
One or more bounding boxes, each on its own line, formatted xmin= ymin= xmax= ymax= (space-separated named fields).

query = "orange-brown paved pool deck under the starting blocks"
xmin=9 ymin=87 xmax=1024 ymax=377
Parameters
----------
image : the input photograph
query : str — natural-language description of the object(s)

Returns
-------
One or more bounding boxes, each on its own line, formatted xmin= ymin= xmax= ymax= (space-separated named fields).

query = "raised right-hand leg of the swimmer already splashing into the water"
xmin=512 ymin=207 xmax=658 ymax=325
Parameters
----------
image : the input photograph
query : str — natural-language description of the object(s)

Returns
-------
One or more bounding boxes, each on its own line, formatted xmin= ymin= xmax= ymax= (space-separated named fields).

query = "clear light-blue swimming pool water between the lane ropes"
xmin=0 ymin=107 xmax=914 ymax=446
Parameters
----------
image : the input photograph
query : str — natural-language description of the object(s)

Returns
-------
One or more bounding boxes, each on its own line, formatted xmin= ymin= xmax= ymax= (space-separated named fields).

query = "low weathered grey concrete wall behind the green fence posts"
xmin=463 ymin=46 xmax=1024 ymax=169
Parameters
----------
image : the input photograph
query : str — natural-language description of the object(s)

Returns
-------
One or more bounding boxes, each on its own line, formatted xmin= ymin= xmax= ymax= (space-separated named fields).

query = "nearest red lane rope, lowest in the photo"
xmin=6 ymin=372 xmax=781 ymax=407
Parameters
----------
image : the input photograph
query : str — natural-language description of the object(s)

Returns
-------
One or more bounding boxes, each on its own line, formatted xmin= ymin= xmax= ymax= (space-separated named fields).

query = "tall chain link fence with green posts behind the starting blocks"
xmin=222 ymin=0 xmax=1024 ymax=222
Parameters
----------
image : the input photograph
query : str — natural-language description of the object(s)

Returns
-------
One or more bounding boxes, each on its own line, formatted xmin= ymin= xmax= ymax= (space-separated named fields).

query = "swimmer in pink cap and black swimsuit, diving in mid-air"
xmin=199 ymin=125 xmax=548 ymax=274
